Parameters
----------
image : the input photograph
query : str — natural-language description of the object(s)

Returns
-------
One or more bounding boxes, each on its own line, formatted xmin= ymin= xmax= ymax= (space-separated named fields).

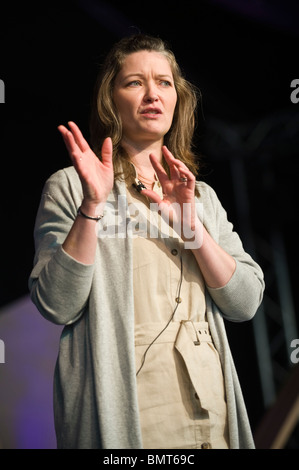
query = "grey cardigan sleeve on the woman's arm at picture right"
xmin=199 ymin=183 xmax=265 ymax=322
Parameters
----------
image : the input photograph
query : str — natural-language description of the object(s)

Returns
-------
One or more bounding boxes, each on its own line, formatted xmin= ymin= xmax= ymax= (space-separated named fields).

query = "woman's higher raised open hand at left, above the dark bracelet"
xmin=58 ymin=121 xmax=114 ymax=211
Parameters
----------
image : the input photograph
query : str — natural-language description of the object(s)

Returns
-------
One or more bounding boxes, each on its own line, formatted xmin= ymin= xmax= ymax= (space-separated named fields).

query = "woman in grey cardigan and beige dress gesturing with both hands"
xmin=30 ymin=35 xmax=264 ymax=449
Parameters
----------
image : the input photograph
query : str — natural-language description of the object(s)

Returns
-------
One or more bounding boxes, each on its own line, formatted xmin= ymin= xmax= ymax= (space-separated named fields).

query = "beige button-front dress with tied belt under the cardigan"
xmin=127 ymin=182 xmax=228 ymax=449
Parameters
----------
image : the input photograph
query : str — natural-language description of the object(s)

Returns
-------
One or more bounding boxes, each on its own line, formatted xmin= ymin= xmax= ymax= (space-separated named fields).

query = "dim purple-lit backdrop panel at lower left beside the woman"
xmin=0 ymin=296 xmax=62 ymax=449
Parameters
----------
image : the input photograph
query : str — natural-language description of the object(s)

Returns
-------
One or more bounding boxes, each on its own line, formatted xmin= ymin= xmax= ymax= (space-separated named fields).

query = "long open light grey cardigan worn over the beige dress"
xmin=29 ymin=167 xmax=264 ymax=449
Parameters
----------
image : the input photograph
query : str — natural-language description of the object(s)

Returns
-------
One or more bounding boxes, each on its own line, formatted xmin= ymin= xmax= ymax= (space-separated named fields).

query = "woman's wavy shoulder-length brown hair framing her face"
xmin=90 ymin=34 xmax=202 ymax=180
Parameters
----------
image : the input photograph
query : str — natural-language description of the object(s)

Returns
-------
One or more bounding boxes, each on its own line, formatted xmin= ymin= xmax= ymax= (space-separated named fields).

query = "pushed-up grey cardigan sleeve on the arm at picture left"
xmin=29 ymin=170 xmax=94 ymax=324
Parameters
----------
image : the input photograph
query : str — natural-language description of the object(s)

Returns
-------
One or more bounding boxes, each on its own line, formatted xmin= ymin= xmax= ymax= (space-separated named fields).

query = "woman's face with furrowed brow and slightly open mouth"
xmin=113 ymin=51 xmax=177 ymax=144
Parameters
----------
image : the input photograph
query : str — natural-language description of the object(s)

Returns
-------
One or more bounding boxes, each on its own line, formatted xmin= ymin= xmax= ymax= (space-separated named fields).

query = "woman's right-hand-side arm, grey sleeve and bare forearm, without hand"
xmin=180 ymin=183 xmax=265 ymax=321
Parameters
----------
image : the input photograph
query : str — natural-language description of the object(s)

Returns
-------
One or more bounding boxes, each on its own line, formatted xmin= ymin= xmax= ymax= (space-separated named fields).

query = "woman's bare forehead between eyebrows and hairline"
xmin=119 ymin=51 xmax=172 ymax=75
